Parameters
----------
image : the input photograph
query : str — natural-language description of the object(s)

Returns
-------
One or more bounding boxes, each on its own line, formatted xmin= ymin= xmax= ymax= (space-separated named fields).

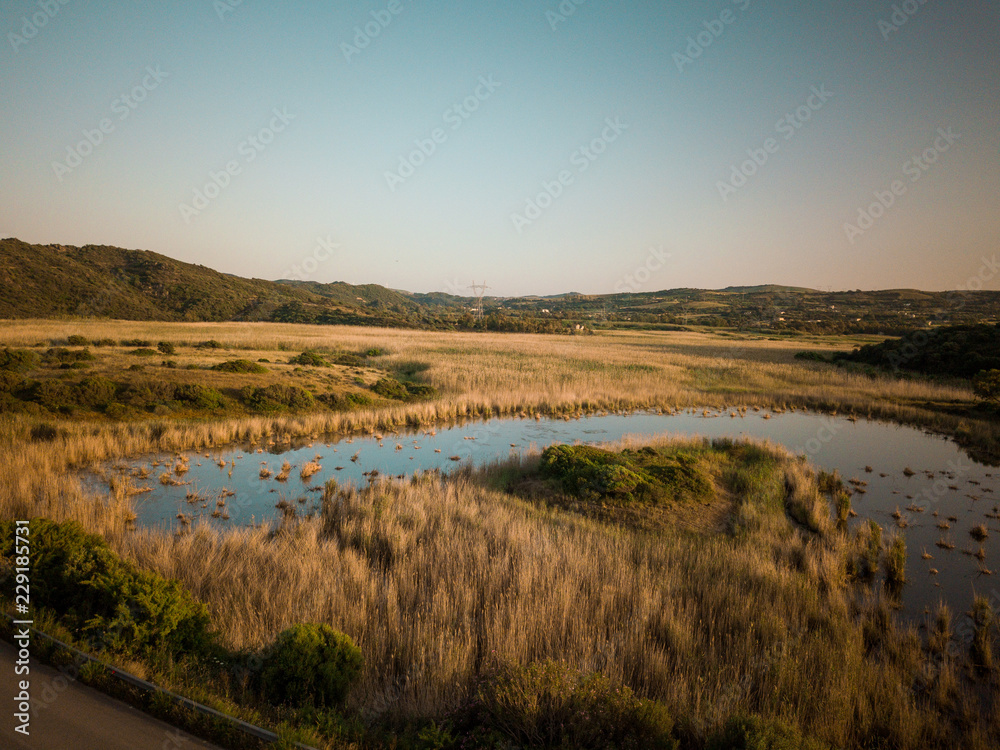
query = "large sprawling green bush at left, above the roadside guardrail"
xmin=0 ymin=518 xmax=211 ymax=655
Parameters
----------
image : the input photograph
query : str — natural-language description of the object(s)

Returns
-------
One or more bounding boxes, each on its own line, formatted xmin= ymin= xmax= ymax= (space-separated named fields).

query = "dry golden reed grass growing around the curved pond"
xmin=0 ymin=321 xmax=998 ymax=748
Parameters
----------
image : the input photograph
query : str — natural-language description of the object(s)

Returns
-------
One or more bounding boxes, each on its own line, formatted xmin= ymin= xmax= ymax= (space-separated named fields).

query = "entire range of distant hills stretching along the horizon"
xmin=0 ymin=238 xmax=1000 ymax=335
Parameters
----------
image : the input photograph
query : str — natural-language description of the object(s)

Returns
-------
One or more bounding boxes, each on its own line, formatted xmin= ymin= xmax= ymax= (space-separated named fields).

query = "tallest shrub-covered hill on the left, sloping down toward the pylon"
xmin=0 ymin=238 xmax=415 ymax=325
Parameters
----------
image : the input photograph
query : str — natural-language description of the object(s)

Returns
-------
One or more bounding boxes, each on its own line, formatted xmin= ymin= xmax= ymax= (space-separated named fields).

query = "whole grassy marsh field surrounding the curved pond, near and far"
xmin=0 ymin=320 xmax=1000 ymax=748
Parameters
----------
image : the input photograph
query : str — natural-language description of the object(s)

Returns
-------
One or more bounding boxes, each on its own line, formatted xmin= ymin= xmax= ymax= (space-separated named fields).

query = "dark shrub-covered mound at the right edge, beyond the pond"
xmin=840 ymin=324 xmax=1000 ymax=378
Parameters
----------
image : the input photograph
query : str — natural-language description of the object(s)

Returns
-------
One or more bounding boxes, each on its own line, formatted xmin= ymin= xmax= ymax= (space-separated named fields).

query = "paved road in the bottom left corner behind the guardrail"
xmin=0 ymin=641 xmax=219 ymax=750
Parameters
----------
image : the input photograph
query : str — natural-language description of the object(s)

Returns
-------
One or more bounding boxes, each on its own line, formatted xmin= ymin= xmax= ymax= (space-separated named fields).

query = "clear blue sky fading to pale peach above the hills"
xmin=0 ymin=0 xmax=1000 ymax=296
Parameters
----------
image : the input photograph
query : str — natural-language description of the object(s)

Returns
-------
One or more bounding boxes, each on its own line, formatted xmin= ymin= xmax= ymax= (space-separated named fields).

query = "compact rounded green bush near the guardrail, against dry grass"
xmin=260 ymin=624 xmax=364 ymax=706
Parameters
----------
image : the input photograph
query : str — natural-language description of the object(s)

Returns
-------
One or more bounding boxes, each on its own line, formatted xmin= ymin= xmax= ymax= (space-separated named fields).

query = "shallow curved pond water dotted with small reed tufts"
xmin=94 ymin=410 xmax=1000 ymax=617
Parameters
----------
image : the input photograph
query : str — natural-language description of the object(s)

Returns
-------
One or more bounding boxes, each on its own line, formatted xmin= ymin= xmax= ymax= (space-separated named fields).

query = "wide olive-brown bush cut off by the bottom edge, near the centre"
xmin=471 ymin=661 xmax=677 ymax=750
